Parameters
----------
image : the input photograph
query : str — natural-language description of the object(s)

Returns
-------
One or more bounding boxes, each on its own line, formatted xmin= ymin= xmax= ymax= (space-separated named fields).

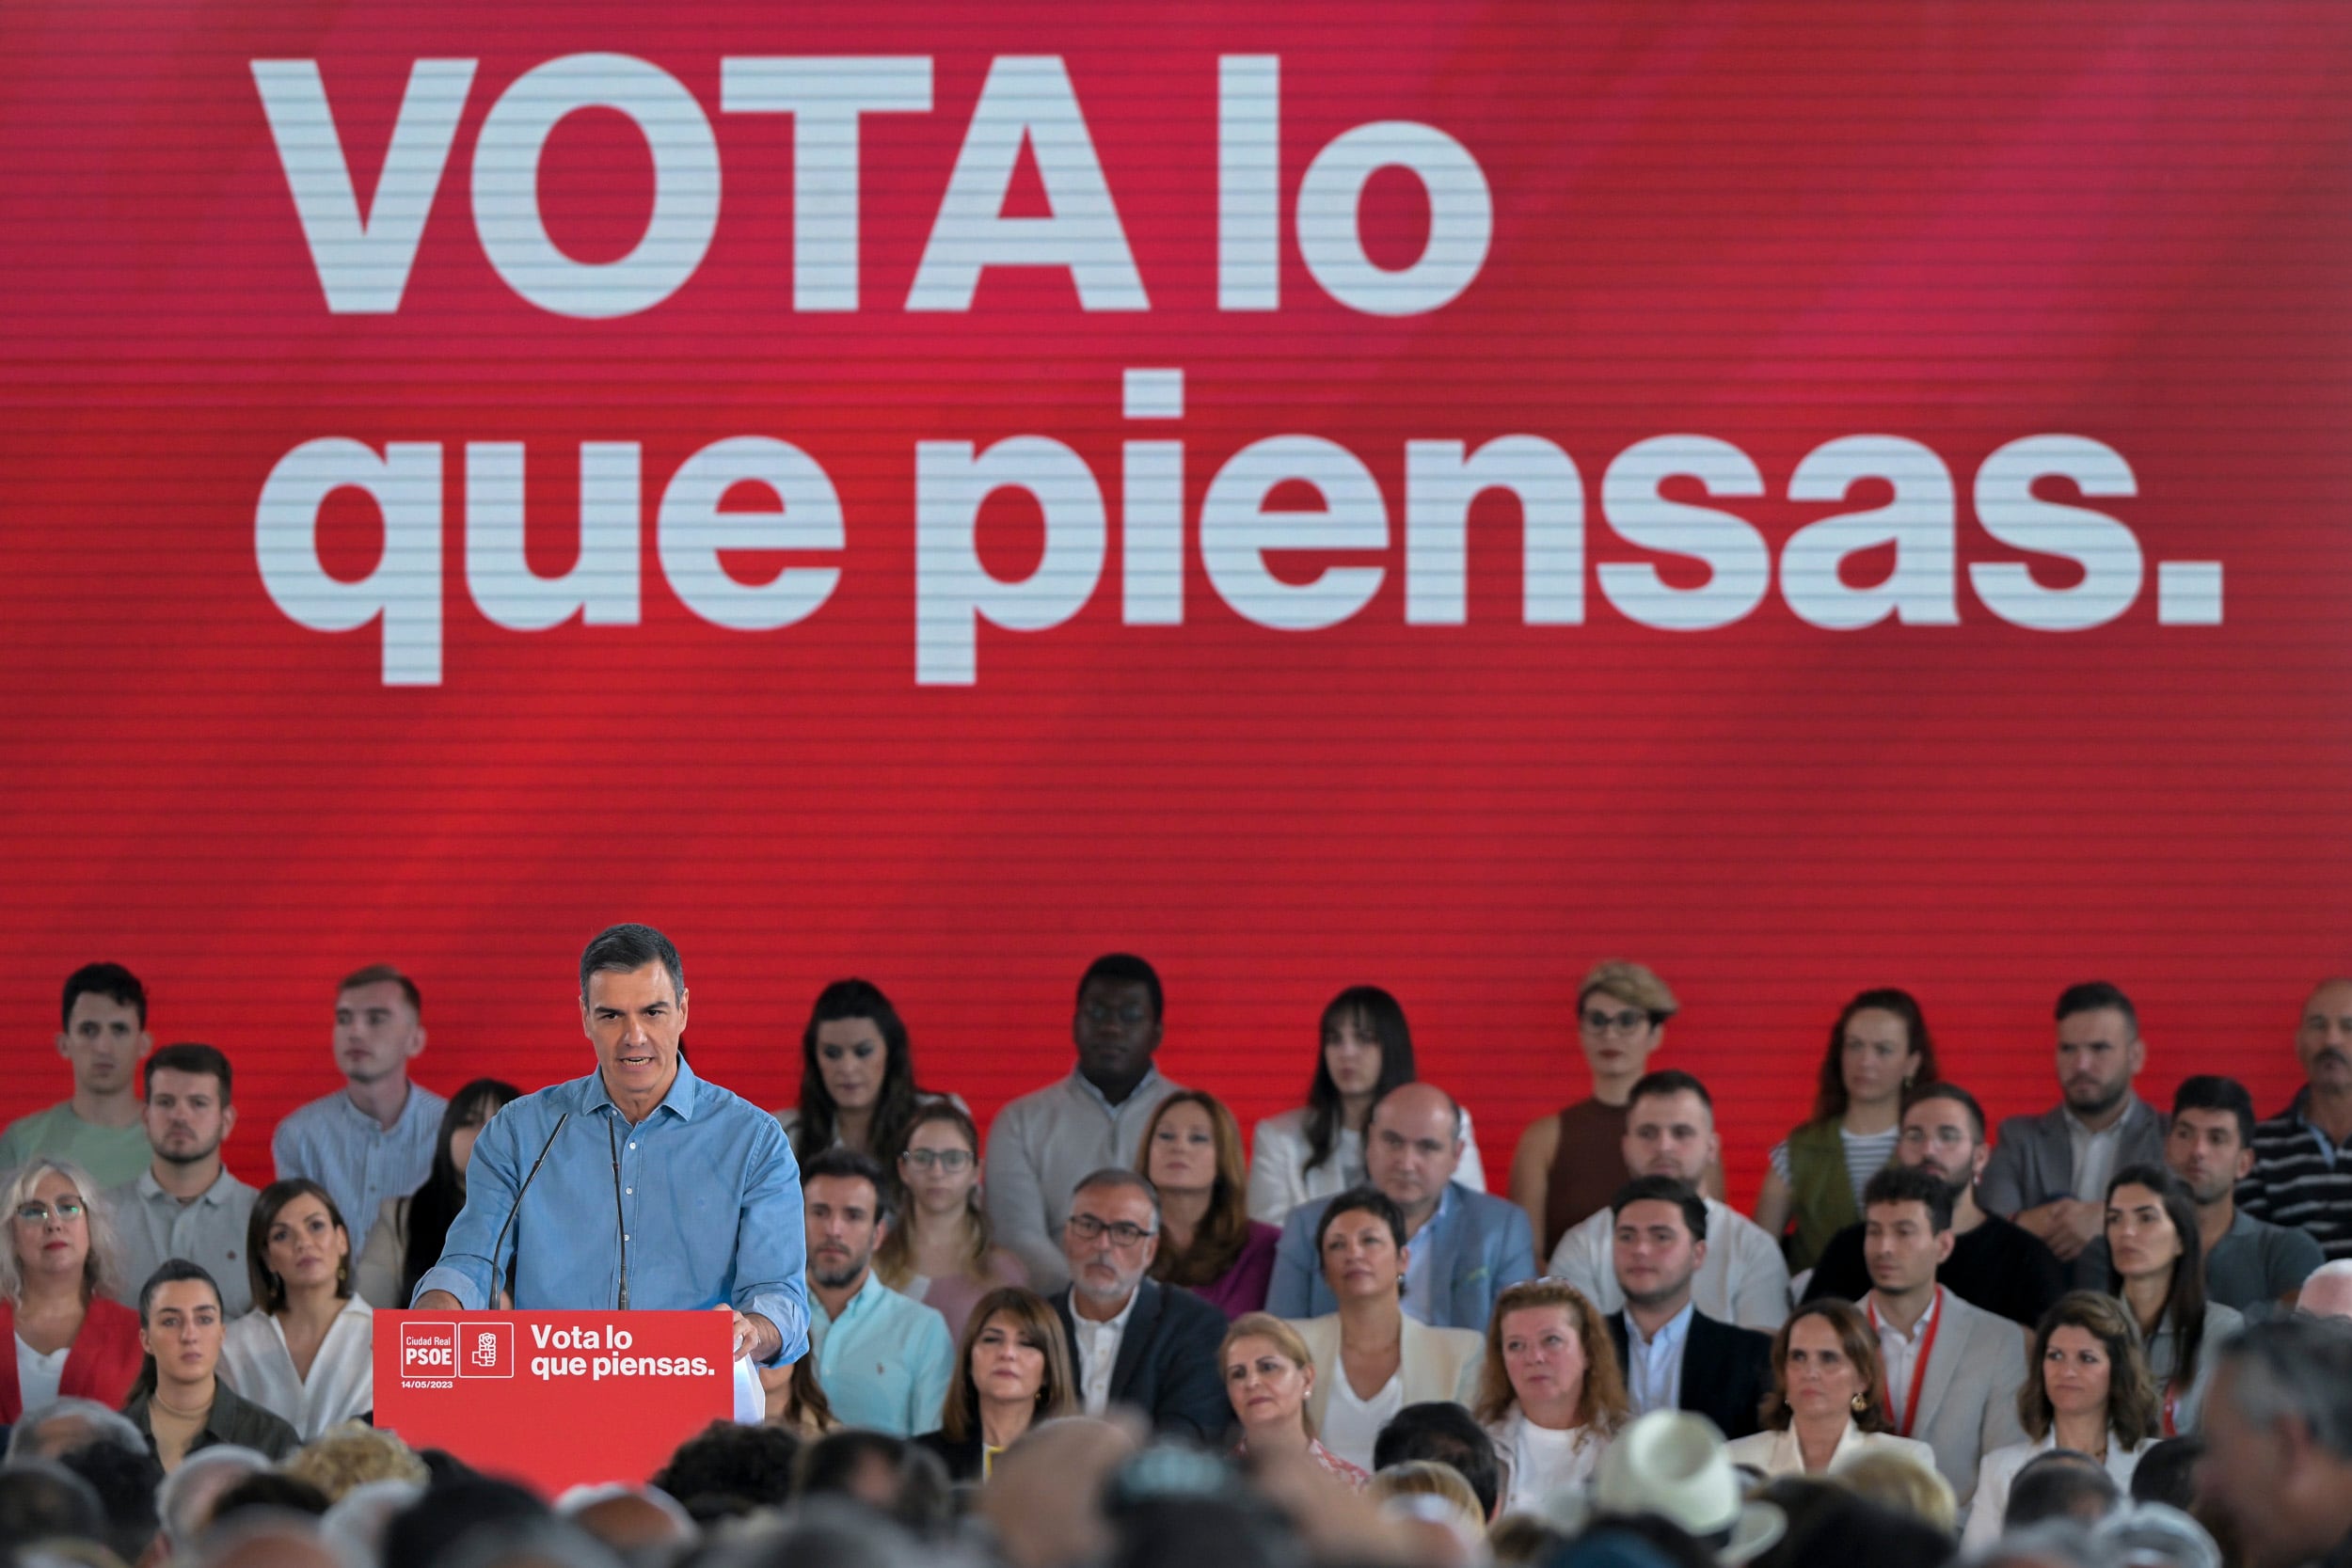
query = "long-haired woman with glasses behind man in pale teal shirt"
xmin=875 ymin=1101 xmax=1028 ymax=1336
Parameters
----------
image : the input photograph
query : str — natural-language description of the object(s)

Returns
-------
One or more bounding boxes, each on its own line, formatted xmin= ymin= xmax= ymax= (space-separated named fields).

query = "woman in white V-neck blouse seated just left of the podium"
xmin=221 ymin=1180 xmax=376 ymax=1441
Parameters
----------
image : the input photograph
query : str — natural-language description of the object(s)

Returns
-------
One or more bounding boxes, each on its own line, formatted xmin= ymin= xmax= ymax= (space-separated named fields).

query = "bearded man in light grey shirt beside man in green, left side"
xmin=106 ymin=1044 xmax=257 ymax=1319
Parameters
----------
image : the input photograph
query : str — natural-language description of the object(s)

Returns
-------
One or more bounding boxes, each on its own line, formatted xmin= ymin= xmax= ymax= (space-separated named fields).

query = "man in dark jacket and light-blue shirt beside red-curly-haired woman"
xmin=1609 ymin=1176 xmax=1772 ymax=1436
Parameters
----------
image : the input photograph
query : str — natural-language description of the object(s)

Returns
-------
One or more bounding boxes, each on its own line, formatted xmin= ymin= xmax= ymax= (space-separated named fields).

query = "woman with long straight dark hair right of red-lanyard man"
xmin=2107 ymin=1166 xmax=2244 ymax=1436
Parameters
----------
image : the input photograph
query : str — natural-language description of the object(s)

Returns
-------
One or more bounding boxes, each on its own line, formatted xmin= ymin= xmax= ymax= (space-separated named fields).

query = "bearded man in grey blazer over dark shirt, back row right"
xmin=1980 ymin=980 xmax=2164 ymax=1291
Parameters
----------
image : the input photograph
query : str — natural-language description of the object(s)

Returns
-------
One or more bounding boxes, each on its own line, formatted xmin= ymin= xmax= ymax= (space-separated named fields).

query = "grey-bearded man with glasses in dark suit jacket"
xmin=1054 ymin=1166 xmax=1232 ymax=1444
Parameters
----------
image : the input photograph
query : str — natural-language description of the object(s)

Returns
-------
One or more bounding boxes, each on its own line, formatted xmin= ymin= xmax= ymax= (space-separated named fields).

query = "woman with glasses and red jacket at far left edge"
xmin=0 ymin=1159 xmax=141 ymax=1425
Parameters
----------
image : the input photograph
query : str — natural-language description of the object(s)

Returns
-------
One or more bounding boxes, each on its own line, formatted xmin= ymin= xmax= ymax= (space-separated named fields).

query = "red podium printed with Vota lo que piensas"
xmin=374 ymin=1312 xmax=734 ymax=1497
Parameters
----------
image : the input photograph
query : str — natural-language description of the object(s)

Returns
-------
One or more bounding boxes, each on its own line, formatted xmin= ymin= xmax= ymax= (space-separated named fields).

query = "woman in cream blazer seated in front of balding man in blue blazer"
xmin=1296 ymin=1187 xmax=1486 ymax=1469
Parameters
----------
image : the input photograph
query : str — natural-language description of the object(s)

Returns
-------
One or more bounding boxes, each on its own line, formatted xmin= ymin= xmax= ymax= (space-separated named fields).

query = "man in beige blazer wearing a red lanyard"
xmin=1863 ymin=1166 xmax=2026 ymax=1507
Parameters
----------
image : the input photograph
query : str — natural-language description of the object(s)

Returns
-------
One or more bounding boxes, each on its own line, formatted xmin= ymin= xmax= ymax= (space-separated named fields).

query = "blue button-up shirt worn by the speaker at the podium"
xmin=417 ymin=1058 xmax=809 ymax=1361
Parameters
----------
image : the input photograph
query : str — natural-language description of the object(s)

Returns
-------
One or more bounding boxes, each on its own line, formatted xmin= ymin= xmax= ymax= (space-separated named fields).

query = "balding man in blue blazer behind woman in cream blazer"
xmin=1265 ymin=1084 xmax=1536 ymax=1333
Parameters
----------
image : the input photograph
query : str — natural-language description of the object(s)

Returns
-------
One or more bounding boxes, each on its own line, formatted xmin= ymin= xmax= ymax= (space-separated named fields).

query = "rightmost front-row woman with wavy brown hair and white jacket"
xmin=1962 ymin=1291 xmax=2157 ymax=1552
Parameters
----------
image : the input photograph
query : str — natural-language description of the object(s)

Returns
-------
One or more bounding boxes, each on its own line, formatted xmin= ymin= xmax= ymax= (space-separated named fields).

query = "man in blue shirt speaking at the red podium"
xmin=414 ymin=927 xmax=809 ymax=1364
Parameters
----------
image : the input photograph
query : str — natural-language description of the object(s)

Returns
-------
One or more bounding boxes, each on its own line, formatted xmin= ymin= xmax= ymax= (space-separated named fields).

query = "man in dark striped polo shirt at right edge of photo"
xmin=2237 ymin=978 xmax=2352 ymax=1258
